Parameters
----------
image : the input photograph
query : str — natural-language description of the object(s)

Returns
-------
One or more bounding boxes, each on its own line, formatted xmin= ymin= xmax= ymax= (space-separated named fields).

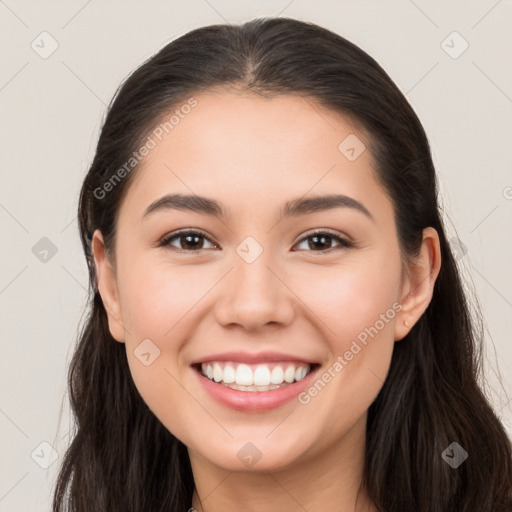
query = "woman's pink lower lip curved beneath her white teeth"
xmin=194 ymin=367 xmax=318 ymax=412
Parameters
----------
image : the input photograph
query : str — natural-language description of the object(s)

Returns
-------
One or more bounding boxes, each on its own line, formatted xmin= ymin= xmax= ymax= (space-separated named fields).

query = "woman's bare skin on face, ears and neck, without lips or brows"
xmin=93 ymin=90 xmax=441 ymax=512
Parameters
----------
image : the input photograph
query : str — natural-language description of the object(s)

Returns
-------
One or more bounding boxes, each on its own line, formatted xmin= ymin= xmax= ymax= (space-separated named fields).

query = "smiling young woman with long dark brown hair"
xmin=53 ymin=18 xmax=512 ymax=512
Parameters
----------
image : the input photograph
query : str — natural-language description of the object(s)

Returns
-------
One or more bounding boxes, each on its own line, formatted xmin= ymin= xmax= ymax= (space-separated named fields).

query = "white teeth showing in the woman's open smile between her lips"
xmin=194 ymin=361 xmax=319 ymax=392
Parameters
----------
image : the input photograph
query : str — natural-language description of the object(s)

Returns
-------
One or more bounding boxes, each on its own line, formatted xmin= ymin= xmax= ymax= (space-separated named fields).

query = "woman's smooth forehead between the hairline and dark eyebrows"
xmin=118 ymin=91 xmax=389 ymax=224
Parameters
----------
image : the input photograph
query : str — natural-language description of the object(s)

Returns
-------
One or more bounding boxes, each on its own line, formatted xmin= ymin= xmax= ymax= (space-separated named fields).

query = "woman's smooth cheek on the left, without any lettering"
xmin=120 ymin=260 xmax=204 ymax=440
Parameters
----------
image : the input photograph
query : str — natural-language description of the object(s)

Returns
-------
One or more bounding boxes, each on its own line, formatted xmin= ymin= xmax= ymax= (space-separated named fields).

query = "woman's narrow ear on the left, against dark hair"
xmin=92 ymin=229 xmax=125 ymax=343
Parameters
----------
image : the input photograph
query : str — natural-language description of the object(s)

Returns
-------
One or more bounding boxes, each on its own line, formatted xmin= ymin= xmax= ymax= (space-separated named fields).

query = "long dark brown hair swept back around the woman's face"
xmin=53 ymin=18 xmax=512 ymax=512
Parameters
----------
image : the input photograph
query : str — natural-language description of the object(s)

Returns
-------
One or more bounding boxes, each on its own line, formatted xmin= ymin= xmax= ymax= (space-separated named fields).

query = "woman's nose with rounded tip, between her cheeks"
xmin=215 ymin=252 xmax=297 ymax=331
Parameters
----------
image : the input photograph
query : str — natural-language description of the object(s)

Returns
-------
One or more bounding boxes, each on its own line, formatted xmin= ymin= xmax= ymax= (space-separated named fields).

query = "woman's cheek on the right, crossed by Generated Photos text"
xmin=297 ymin=257 xmax=400 ymax=434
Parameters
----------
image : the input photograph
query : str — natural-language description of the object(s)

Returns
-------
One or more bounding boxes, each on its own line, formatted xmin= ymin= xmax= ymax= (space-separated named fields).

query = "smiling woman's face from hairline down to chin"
xmin=94 ymin=91 xmax=436 ymax=471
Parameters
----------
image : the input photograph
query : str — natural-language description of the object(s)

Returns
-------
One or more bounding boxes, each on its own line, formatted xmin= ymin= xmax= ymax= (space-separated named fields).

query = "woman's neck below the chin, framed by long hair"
xmin=189 ymin=415 xmax=377 ymax=512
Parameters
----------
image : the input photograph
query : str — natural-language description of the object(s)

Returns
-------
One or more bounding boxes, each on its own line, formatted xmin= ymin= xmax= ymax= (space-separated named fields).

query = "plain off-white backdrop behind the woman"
xmin=0 ymin=0 xmax=512 ymax=512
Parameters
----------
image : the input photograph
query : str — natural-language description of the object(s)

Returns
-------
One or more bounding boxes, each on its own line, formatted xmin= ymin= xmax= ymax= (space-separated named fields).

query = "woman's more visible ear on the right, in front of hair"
xmin=395 ymin=227 xmax=441 ymax=341
